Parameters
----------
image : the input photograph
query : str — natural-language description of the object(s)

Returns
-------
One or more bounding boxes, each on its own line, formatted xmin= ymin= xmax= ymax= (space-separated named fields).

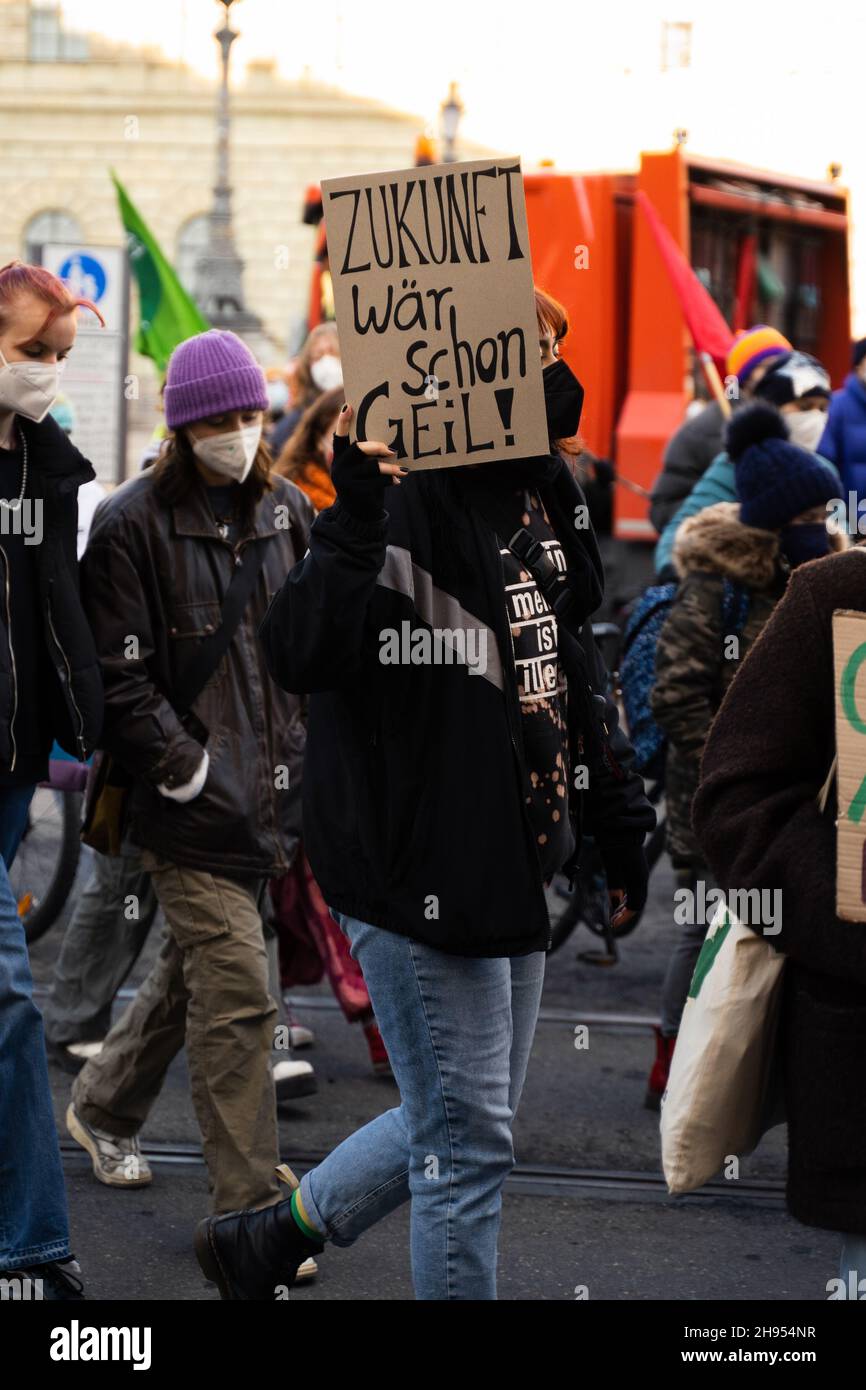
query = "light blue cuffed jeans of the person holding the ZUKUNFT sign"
xmin=300 ymin=912 xmax=545 ymax=1300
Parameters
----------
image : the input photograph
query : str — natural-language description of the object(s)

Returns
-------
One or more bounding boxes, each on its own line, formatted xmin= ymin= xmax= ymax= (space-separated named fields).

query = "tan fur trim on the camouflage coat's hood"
xmin=671 ymin=502 xmax=847 ymax=589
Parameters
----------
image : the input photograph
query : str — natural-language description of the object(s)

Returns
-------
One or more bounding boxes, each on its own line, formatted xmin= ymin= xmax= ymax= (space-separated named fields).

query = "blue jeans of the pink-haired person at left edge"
xmin=0 ymin=787 xmax=70 ymax=1269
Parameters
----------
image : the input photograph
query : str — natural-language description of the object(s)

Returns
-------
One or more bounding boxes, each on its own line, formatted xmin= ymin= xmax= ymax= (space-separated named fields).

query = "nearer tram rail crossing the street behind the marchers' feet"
xmin=60 ymin=1140 xmax=785 ymax=1207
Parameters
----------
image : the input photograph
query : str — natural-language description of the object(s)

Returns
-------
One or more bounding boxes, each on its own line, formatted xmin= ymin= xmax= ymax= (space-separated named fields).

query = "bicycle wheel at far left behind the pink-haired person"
xmin=10 ymin=787 xmax=82 ymax=941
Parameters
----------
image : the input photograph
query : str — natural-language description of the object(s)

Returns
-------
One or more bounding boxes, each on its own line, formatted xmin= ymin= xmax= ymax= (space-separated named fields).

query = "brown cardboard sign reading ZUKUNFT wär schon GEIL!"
xmin=322 ymin=158 xmax=549 ymax=468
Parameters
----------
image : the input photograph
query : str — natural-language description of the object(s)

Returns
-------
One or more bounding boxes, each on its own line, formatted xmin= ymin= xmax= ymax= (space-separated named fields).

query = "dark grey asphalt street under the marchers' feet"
xmin=32 ymin=860 xmax=840 ymax=1301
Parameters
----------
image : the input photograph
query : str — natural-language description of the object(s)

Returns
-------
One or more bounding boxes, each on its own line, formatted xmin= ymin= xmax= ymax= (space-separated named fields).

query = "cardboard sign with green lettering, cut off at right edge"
xmin=833 ymin=609 xmax=866 ymax=922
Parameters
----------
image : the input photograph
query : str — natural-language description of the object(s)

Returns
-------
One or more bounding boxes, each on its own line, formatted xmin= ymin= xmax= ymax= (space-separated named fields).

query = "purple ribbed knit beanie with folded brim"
xmin=163 ymin=328 xmax=268 ymax=430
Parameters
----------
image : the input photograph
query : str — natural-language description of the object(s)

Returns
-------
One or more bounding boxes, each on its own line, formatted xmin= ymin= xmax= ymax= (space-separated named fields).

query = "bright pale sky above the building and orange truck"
xmin=52 ymin=0 xmax=866 ymax=334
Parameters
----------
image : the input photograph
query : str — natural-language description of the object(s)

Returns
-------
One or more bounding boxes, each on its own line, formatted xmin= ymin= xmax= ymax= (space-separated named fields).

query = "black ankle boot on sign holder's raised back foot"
xmin=195 ymin=1201 xmax=324 ymax=1302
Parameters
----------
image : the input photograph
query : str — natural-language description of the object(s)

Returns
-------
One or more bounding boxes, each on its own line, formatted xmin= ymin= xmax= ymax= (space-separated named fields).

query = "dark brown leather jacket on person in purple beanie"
xmin=82 ymin=468 xmax=313 ymax=876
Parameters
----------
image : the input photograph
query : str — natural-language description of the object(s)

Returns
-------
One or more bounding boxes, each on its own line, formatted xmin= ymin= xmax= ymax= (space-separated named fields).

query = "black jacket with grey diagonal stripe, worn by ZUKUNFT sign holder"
xmin=260 ymin=455 xmax=655 ymax=956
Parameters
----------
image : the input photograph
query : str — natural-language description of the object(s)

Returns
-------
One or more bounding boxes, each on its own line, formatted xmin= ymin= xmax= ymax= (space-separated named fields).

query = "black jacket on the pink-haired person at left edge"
xmin=0 ymin=416 xmax=103 ymax=771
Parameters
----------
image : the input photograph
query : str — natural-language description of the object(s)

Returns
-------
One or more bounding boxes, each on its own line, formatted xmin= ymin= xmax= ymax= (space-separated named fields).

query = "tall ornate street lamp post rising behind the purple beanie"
xmin=195 ymin=0 xmax=261 ymax=332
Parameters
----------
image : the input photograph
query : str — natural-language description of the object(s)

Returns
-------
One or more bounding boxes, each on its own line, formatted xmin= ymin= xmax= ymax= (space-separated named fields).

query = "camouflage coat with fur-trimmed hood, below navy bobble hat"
xmin=652 ymin=502 xmax=788 ymax=869
